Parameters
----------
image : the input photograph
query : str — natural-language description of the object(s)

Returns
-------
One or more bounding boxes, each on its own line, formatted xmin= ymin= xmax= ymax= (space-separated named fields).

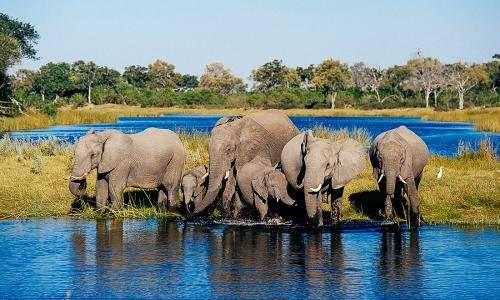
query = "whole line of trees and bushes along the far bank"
xmin=0 ymin=14 xmax=500 ymax=114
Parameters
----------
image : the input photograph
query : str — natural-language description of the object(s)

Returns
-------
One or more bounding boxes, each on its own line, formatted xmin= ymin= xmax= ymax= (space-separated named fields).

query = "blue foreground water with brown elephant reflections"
xmin=0 ymin=218 xmax=500 ymax=299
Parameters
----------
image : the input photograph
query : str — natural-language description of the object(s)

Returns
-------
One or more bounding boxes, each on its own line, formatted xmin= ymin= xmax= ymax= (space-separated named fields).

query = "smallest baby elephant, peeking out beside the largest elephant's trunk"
xmin=181 ymin=166 xmax=208 ymax=213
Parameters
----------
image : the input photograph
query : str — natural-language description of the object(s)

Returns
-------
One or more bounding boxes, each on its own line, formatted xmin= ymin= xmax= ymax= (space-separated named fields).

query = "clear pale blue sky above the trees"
xmin=0 ymin=0 xmax=500 ymax=78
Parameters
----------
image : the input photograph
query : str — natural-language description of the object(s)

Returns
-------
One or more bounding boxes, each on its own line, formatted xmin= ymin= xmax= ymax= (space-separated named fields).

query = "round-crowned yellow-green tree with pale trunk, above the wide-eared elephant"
xmin=312 ymin=58 xmax=350 ymax=109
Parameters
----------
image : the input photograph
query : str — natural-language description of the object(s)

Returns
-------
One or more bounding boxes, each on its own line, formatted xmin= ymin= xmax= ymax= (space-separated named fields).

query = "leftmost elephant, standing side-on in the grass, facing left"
xmin=69 ymin=128 xmax=184 ymax=210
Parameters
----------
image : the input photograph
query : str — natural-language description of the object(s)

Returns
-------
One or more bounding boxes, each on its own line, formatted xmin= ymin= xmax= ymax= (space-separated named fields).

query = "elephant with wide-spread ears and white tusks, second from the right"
xmin=281 ymin=130 xmax=366 ymax=226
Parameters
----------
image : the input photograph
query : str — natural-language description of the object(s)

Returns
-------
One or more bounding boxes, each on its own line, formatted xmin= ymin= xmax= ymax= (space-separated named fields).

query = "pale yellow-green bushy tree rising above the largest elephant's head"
xmin=200 ymin=62 xmax=246 ymax=94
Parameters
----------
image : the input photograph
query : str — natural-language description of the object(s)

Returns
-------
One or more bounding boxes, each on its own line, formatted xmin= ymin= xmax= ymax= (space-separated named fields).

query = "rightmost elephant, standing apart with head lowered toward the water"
xmin=370 ymin=126 xmax=429 ymax=226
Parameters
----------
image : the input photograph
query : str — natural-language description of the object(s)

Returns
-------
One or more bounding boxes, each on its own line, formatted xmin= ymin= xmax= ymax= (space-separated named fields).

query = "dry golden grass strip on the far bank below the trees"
xmin=0 ymin=104 xmax=500 ymax=132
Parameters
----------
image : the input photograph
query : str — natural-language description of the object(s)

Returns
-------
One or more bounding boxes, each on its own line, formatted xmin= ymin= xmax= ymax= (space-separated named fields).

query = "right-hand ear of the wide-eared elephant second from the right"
xmin=332 ymin=138 xmax=366 ymax=189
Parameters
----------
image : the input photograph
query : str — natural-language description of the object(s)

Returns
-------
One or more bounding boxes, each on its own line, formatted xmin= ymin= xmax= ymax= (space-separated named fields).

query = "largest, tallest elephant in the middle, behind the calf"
xmin=194 ymin=110 xmax=299 ymax=216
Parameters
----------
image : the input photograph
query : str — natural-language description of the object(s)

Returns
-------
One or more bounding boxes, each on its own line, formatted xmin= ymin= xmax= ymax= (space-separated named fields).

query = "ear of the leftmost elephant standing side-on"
xmin=97 ymin=132 xmax=132 ymax=173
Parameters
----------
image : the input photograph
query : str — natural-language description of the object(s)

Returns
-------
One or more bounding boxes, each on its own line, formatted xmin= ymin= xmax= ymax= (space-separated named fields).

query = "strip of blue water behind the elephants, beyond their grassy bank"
xmin=5 ymin=115 xmax=500 ymax=156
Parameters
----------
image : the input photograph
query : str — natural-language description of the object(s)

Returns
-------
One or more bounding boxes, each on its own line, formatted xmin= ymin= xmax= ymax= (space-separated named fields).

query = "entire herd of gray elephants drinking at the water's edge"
xmin=69 ymin=110 xmax=429 ymax=227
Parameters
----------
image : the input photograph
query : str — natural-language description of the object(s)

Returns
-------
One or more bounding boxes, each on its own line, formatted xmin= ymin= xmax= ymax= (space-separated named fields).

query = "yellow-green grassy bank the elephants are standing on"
xmin=0 ymin=128 xmax=500 ymax=225
